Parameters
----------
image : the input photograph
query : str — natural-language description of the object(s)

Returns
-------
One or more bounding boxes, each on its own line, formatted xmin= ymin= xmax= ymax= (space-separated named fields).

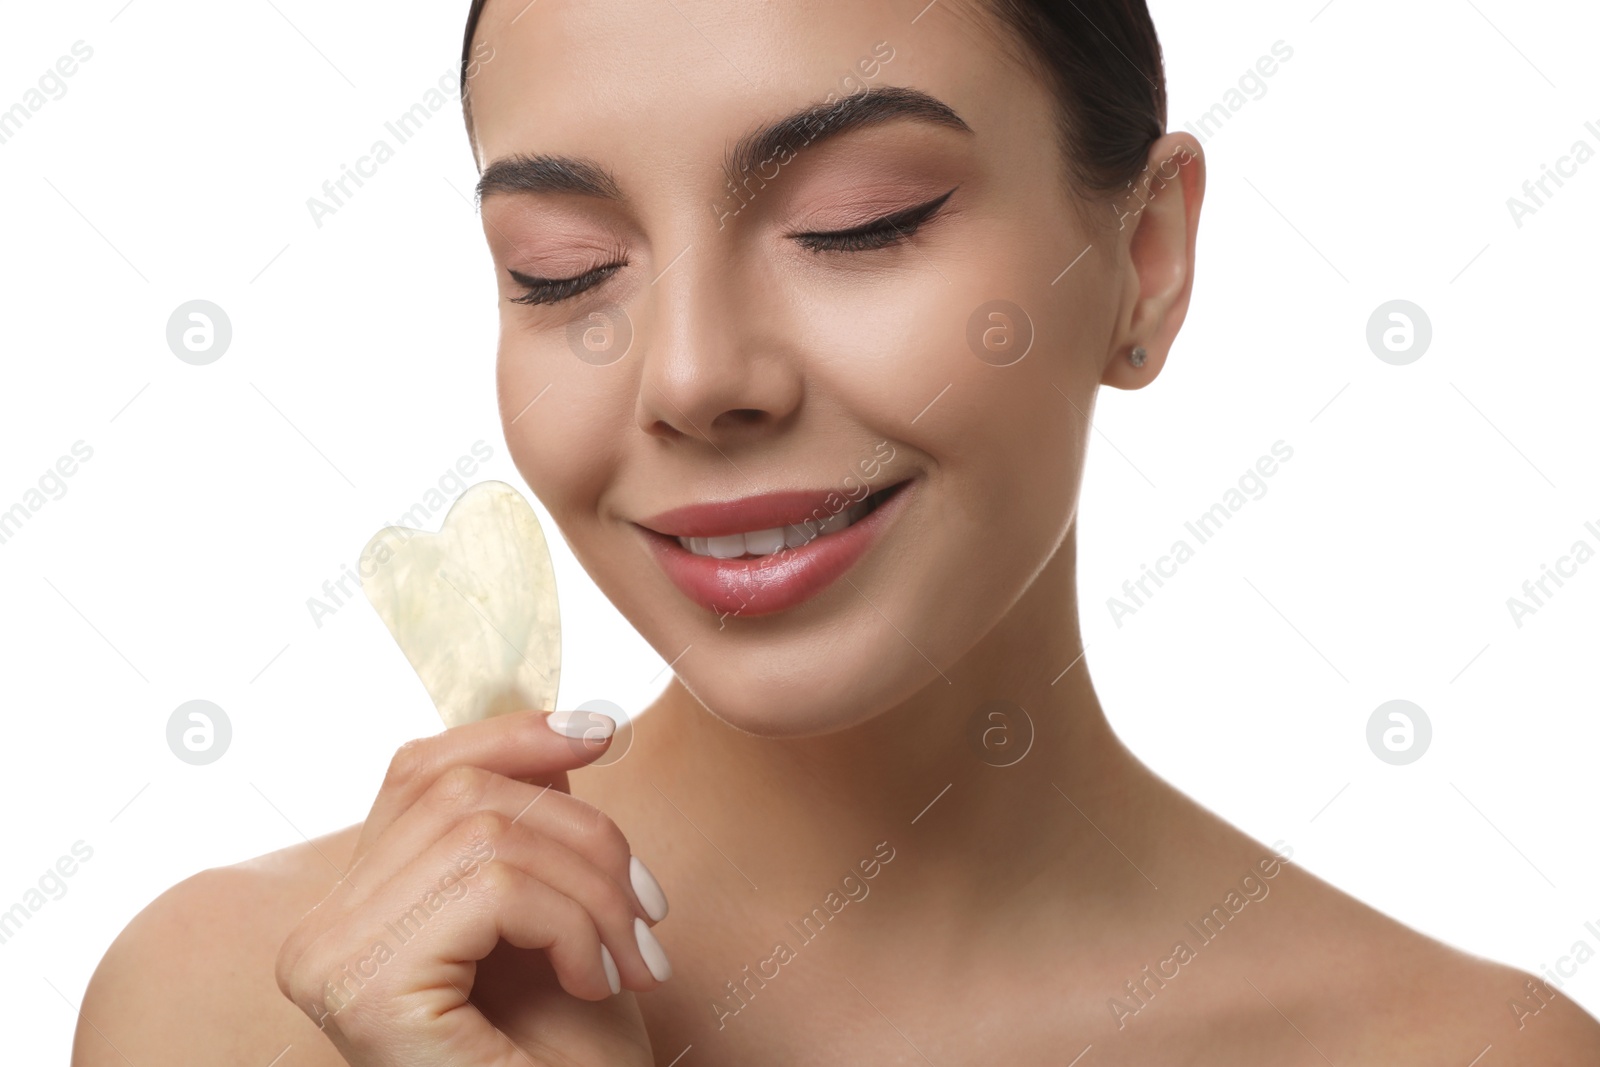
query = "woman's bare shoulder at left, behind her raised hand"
xmin=72 ymin=824 xmax=360 ymax=1067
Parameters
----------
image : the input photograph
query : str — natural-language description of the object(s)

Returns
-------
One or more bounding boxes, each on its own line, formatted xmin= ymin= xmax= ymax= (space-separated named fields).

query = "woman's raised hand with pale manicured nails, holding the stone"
xmin=277 ymin=712 xmax=670 ymax=1067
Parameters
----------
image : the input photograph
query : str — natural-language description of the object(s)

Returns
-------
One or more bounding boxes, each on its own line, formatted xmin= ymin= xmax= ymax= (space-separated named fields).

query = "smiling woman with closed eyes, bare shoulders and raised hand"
xmin=75 ymin=0 xmax=1600 ymax=1067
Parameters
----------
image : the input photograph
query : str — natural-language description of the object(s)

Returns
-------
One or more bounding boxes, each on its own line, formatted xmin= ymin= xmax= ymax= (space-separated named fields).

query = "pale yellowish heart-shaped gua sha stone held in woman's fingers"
xmin=360 ymin=482 xmax=562 ymax=726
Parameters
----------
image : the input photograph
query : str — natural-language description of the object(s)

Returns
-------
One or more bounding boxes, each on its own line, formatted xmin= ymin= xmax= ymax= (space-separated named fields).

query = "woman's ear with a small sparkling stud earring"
xmin=1101 ymin=133 xmax=1205 ymax=389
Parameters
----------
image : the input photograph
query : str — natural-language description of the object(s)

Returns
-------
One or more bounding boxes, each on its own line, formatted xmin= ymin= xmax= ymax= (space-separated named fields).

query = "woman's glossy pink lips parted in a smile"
xmin=635 ymin=478 xmax=915 ymax=617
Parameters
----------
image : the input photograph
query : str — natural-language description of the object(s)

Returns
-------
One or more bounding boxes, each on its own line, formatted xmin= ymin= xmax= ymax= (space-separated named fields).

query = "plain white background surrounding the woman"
xmin=0 ymin=0 xmax=1600 ymax=1062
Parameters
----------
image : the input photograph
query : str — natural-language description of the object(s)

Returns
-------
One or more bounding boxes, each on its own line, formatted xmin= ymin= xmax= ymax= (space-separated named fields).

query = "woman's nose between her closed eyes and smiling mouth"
xmin=635 ymin=248 xmax=803 ymax=448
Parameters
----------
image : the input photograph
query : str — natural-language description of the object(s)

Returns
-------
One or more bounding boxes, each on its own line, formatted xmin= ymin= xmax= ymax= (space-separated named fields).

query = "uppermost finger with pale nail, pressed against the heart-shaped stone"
xmin=352 ymin=710 xmax=614 ymax=859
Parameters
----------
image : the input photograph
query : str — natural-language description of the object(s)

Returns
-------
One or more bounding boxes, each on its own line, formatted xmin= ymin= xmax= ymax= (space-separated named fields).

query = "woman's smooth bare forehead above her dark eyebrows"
xmin=470 ymin=0 xmax=1048 ymax=184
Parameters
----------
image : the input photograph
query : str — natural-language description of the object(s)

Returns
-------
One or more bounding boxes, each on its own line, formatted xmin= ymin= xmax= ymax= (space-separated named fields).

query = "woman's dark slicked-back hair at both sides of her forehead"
xmin=461 ymin=0 xmax=1166 ymax=192
